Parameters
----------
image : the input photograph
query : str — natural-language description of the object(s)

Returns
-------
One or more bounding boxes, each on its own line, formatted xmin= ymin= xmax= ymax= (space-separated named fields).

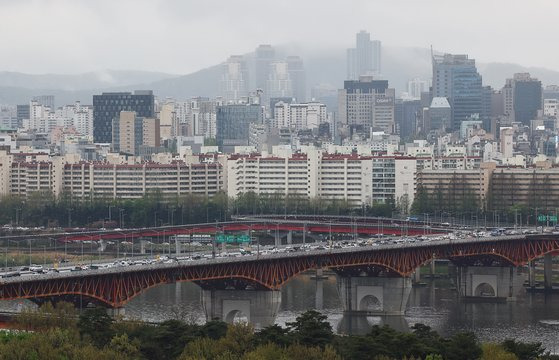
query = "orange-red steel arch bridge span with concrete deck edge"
xmin=0 ymin=235 xmax=559 ymax=308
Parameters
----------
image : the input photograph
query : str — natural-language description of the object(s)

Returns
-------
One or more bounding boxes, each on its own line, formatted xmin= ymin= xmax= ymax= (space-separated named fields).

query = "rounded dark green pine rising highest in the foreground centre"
xmin=287 ymin=310 xmax=334 ymax=347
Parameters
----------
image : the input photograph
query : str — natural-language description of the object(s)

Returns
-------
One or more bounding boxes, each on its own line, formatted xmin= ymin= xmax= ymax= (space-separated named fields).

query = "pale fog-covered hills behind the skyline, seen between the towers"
xmin=0 ymin=45 xmax=559 ymax=106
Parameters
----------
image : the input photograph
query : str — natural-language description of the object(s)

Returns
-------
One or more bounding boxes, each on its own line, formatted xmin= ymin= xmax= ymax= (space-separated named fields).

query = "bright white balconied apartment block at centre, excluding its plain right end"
xmin=227 ymin=151 xmax=372 ymax=206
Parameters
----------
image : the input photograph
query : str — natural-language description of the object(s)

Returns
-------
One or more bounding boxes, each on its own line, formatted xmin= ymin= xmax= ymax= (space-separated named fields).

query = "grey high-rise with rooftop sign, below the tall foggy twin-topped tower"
xmin=338 ymin=76 xmax=395 ymax=133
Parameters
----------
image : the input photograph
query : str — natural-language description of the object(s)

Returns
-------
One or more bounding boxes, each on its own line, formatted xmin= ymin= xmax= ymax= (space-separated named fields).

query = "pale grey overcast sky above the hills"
xmin=0 ymin=0 xmax=559 ymax=74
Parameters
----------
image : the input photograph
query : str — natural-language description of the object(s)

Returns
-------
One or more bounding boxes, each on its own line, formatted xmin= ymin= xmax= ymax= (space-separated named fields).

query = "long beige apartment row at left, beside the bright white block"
xmin=0 ymin=152 xmax=225 ymax=199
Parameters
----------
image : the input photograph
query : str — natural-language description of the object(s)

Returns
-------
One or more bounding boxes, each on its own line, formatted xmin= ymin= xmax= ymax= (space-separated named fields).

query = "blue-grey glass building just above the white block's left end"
xmin=216 ymin=104 xmax=264 ymax=152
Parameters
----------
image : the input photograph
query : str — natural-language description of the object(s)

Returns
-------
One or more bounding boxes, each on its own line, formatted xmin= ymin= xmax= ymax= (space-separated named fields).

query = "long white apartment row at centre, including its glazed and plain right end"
xmin=227 ymin=149 xmax=417 ymax=207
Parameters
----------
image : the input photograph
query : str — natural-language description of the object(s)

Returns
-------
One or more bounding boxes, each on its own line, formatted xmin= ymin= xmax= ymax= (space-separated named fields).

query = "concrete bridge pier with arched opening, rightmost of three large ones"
xmin=456 ymin=266 xmax=524 ymax=301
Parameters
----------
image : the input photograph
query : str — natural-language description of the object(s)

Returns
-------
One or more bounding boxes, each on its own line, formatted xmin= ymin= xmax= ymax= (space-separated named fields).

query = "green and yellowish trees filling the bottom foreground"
xmin=8 ymin=303 xmax=558 ymax=360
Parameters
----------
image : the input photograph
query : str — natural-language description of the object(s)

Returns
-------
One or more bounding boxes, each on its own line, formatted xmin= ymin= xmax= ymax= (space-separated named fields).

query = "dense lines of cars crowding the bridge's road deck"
xmin=0 ymin=222 xmax=548 ymax=280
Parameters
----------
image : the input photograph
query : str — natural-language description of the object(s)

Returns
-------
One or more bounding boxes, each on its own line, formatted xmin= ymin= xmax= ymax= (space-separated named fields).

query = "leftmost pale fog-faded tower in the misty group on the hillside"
xmin=219 ymin=55 xmax=249 ymax=102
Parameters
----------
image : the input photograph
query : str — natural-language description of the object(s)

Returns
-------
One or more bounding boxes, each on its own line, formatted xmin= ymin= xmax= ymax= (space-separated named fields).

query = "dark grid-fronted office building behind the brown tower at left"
xmin=93 ymin=90 xmax=155 ymax=143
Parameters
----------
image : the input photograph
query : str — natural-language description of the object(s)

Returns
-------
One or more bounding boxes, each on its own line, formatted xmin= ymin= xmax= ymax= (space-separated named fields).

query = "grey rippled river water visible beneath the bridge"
xmin=0 ymin=274 xmax=559 ymax=353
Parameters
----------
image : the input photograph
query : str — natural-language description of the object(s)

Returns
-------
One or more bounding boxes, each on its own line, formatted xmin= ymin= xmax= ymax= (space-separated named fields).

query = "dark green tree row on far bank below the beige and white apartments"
xmin=0 ymin=192 xmax=395 ymax=227
